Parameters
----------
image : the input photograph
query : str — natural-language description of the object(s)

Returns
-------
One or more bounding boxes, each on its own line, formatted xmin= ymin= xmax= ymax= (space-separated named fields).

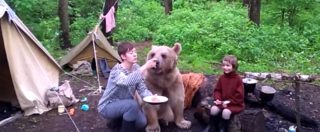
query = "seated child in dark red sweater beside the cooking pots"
xmin=210 ymin=55 xmax=244 ymax=132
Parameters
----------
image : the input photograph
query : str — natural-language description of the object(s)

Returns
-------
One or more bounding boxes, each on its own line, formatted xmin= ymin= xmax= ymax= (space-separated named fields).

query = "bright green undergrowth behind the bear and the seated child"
xmin=115 ymin=0 xmax=320 ymax=73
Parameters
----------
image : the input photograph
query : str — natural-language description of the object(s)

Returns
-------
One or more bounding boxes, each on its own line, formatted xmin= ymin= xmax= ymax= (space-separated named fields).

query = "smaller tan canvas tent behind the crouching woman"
xmin=60 ymin=28 xmax=121 ymax=75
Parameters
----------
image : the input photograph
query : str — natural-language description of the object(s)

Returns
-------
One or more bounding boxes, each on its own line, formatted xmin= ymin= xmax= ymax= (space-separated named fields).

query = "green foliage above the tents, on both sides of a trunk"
xmin=8 ymin=0 xmax=104 ymax=58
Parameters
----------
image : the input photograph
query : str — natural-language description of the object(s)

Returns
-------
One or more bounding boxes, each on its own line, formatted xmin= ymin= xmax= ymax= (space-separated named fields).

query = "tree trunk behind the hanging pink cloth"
xmin=100 ymin=0 xmax=118 ymax=45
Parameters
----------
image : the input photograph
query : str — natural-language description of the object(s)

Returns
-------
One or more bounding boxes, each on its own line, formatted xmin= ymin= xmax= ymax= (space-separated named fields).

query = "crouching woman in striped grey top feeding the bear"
xmin=98 ymin=42 xmax=156 ymax=132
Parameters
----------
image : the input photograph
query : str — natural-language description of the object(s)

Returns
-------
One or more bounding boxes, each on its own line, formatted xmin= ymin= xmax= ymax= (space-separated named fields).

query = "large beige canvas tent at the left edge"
xmin=0 ymin=0 xmax=61 ymax=115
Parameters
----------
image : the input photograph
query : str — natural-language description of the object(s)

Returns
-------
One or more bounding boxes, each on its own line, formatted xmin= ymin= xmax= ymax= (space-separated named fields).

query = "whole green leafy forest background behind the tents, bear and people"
xmin=7 ymin=0 xmax=320 ymax=74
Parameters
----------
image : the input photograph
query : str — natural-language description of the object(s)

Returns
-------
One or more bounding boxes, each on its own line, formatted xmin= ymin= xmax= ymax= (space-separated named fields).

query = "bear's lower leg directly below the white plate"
xmin=144 ymin=105 xmax=161 ymax=132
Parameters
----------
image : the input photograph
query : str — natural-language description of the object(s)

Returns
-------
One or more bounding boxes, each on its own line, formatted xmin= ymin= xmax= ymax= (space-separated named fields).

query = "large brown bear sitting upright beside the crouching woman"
xmin=144 ymin=43 xmax=191 ymax=132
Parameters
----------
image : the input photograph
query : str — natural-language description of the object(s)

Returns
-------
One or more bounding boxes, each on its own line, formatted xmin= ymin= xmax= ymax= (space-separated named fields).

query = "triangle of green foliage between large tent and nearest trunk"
xmin=8 ymin=0 xmax=61 ymax=57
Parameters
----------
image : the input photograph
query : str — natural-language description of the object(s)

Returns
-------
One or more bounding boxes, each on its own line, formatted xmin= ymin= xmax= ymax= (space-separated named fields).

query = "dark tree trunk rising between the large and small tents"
xmin=58 ymin=0 xmax=71 ymax=49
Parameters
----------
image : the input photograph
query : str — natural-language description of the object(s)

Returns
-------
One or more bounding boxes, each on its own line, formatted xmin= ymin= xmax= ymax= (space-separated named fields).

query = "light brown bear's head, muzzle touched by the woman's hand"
xmin=147 ymin=43 xmax=181 ymax=74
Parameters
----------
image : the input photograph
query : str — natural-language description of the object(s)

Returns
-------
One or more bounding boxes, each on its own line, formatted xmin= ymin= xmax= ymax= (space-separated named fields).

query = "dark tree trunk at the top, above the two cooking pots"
xmin=249 ymin=0 xmax=261 ymax=26
